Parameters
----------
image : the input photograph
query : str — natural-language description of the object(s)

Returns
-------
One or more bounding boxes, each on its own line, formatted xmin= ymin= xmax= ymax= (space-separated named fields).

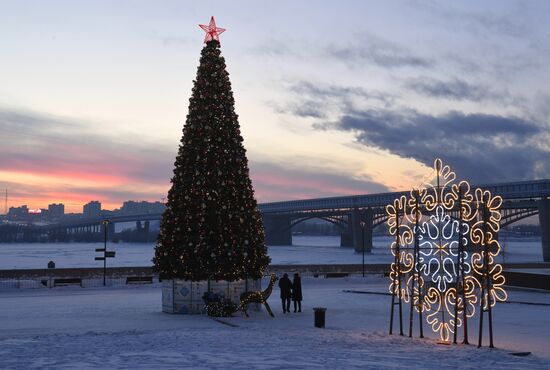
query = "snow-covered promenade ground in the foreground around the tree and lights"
xmin=0 ymin=276 xmax=550 ymax=369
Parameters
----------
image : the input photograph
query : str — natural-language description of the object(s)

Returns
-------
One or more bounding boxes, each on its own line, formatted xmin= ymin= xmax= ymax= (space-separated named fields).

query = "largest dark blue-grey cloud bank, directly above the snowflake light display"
xmin=316 ymin=109 xmax=550 ymax=182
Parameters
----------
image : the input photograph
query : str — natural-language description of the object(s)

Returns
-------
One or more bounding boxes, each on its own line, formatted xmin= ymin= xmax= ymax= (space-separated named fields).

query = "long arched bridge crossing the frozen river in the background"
xmin=45 ymin=179 xmax=550 ymax=262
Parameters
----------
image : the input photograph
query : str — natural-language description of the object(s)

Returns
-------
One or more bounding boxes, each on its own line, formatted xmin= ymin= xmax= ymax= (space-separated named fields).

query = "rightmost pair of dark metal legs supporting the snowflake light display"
xmin=477 ymin=203 xmax=495 ymax=348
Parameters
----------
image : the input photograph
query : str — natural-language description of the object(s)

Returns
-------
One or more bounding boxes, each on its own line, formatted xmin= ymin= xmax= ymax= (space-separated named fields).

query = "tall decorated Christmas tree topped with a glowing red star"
xmin=153 ymin=17 xmax=270 ymax=281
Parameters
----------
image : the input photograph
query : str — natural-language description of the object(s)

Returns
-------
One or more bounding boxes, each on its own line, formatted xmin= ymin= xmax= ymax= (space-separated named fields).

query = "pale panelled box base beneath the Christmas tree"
xmin=162 ymin=279 xmax=261 ymax=315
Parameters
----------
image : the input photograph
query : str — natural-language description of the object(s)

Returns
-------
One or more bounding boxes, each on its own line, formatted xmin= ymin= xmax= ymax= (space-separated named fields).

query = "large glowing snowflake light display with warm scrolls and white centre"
xmin=386 ymin=159 xmax=507 ymax=347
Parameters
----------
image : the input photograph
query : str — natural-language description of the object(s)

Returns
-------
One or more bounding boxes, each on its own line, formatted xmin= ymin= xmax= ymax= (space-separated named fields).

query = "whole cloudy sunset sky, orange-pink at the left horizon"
xmin=0 ymin=0 xmax=550 ymax=213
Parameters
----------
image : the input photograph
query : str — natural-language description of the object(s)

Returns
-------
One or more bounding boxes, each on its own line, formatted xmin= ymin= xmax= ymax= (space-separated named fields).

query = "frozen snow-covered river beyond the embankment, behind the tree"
xmin=0 ymin=236 xmax=542 ymax=269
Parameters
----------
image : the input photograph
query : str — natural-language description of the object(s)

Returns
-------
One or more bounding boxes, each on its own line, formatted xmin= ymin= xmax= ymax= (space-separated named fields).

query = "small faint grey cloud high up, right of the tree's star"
xmin=324 ymin=34 xmax=435 ymax=69
